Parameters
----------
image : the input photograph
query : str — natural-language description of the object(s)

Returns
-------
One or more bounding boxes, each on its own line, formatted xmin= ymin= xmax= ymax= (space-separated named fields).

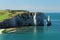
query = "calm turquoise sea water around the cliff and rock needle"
xmin=0 ymin=13 xmax=60 ymax=40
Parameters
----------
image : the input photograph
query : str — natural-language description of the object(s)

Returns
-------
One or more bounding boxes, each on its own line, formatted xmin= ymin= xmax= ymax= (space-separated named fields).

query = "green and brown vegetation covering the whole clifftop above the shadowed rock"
xmin=0 ymin=9 xmax=34 ymax=22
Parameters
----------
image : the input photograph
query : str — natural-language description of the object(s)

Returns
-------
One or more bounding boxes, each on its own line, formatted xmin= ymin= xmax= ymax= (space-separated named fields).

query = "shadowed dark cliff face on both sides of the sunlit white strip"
xmin=0 ymin=12 xmax=45 ymax=28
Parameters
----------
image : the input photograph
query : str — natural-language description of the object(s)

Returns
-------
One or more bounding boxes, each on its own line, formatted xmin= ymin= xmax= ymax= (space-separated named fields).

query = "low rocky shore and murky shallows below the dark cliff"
xmin=0 ymin=26 xmax=34 ymax=34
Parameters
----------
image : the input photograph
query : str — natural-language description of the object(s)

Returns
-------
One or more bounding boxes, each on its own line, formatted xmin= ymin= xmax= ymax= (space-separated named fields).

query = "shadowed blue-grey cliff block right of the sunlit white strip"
xmin=36 ymin=12 xmax=46 ymax=26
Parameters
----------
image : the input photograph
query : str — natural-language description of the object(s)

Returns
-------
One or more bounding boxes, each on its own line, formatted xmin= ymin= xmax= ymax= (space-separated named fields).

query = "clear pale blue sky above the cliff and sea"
xmin=0 ymin=0 xmax=60 ymax=12
